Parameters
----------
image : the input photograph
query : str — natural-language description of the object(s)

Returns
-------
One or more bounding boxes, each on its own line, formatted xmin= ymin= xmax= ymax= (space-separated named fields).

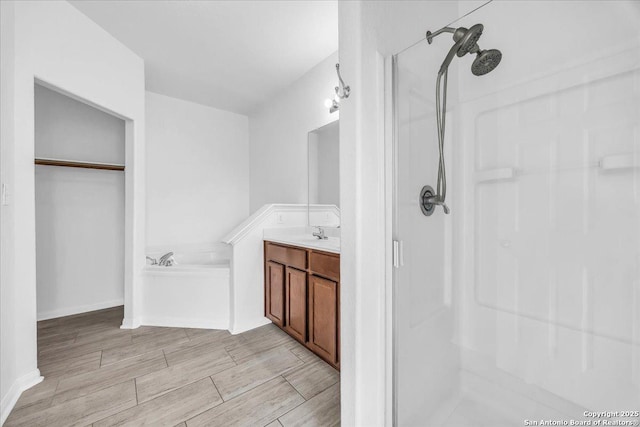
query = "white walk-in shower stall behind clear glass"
xmin=393 ymin=1 xmax=640 ymax=427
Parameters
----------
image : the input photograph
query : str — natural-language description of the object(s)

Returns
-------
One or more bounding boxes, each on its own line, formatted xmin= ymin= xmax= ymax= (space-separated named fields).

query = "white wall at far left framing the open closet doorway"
xmin=0 ymin=1 xmax=145 ymax=420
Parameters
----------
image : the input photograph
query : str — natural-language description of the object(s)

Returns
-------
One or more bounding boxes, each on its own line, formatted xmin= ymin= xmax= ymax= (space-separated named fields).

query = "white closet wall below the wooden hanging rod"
xmin=36 ymin=166 xmax=124 ymax=320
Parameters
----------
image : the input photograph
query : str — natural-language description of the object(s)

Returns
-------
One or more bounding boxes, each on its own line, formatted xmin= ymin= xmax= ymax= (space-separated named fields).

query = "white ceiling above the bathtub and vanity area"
xmin=70 ymin=0 xmax=338 ymax=114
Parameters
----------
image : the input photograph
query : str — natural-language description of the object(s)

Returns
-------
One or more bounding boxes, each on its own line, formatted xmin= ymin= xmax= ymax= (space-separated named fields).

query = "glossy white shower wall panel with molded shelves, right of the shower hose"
xmin=456 ymin=20 xmax=640 ymax=420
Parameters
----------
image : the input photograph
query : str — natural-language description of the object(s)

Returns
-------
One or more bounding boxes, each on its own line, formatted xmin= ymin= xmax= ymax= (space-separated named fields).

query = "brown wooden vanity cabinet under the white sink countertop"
xmin=264 ymin=242 xmax=340 ymax=369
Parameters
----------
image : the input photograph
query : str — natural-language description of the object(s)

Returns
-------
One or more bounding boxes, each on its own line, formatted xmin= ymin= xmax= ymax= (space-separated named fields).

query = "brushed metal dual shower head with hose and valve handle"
xmin=420 ymin=24 xmax=502 ymax=216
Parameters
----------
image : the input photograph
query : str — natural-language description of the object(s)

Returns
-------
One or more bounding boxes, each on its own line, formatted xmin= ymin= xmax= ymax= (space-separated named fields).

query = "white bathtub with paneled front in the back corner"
xmin=141 ymin=248 xmax=230 ymax=329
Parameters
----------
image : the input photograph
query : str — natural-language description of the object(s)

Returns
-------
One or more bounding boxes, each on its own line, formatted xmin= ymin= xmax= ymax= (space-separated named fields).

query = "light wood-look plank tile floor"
xmin=5 ymin=307 xmax=340 ymax=427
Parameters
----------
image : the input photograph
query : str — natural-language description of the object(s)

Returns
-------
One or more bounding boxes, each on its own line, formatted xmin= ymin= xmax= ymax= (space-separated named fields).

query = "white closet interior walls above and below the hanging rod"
xmin=35 ymin=85 xmax=125 ymax=320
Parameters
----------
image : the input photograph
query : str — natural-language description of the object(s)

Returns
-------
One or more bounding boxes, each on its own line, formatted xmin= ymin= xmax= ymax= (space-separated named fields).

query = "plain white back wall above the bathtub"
xmin=146 ymin=92 xmax=249 ymax=252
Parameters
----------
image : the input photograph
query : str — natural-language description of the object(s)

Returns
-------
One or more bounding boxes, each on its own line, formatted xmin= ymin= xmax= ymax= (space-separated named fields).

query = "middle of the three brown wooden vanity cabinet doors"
xmin=284 ymin=267 xmax=307 ymax=343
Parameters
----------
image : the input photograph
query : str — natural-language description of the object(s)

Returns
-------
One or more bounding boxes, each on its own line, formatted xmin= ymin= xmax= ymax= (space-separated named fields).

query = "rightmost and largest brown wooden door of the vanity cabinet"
xmin=308 ymin=276 xmax=338 ymax=365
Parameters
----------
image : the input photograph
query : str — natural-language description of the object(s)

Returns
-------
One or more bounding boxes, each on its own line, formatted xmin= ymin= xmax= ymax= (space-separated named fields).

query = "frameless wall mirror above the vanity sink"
xmin=307 ymin=120 xmax=340 ymax=226
